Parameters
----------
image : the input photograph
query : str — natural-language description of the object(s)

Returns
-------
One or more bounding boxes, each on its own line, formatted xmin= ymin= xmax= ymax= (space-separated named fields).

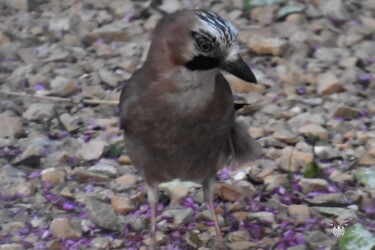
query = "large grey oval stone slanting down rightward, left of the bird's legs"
xmin=86 ymin=199 xmax=119 ymax=231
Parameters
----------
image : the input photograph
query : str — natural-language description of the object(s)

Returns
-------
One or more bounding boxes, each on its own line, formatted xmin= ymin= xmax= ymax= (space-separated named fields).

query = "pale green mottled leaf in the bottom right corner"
xmin=339 ymin=223 xmax=375 ymax=250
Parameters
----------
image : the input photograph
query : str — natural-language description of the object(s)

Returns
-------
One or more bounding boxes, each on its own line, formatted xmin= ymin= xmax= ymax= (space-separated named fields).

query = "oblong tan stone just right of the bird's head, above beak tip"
xmin=248 ymin=36 xmax=287 ymax=56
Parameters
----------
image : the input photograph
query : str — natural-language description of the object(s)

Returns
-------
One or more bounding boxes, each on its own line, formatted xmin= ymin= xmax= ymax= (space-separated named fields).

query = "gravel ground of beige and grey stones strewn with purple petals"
xmin=0 ymin=0 xmax=375 ymax=250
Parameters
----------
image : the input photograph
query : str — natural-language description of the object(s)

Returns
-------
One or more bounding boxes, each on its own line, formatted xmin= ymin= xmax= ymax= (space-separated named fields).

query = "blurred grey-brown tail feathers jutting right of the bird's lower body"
xmin=229 ymin=121 xmax=263 ymax=168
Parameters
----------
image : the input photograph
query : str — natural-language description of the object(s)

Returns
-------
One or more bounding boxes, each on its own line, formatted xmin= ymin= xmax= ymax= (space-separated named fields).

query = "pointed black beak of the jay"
xmin=219 ymin=56 xmax=257 ymax=83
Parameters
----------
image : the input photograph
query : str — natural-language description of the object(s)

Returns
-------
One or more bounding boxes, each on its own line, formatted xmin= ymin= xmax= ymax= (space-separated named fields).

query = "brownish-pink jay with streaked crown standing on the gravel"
xmin=119 ymin=9 xmax=261 ymax=247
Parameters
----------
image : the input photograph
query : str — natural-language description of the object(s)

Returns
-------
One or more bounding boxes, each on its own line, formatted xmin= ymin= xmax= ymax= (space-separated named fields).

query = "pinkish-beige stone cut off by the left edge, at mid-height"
xmin=0 ymin=115 xmax=24 ymax=139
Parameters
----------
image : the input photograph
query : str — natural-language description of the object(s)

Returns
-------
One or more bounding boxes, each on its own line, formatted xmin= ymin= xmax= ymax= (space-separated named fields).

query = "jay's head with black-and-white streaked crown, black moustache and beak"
xmin=150 ymin=10 xmax=256 ymax=83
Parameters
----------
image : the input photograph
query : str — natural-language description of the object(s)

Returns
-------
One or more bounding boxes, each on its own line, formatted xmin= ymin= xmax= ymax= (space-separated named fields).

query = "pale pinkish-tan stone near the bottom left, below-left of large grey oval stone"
xmin=50 ymin=218 xmax=82 ymax=240
